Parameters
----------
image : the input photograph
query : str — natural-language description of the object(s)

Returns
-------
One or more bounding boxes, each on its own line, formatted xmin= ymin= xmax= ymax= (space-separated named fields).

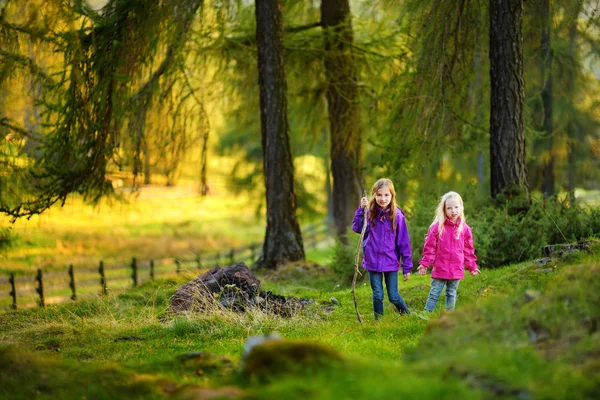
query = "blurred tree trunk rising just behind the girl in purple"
xmin=321 ymin=0 xmax=361 ymax=243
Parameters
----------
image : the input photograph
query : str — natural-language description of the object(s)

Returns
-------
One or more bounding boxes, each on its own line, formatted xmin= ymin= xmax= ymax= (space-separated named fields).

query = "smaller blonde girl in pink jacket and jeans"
xmin=417 ymin=192 xmax=480 ymax=312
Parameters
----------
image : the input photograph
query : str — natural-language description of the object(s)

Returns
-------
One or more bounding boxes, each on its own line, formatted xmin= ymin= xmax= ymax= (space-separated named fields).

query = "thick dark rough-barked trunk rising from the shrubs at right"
xmin=490 ymin=0 xmax=530 ymax=203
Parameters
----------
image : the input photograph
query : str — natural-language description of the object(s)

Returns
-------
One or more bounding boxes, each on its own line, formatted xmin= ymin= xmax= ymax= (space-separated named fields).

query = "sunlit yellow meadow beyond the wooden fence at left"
xmin=2 ymin=187 xmax=264 ymax=271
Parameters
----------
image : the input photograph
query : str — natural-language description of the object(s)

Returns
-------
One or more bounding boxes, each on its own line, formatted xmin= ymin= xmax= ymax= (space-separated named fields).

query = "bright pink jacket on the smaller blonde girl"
xmin=419 ymin=219 xmax=477 ymax=279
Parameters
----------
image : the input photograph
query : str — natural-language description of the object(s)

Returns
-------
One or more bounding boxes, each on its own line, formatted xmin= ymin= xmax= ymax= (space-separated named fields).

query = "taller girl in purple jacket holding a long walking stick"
xmin=352 ymin=179 xmax=413 ymax=319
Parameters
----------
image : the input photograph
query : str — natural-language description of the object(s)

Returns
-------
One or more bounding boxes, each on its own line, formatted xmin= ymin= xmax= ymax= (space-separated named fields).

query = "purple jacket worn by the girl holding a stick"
xmin=352 ymin=207 xmax=412 ymax=274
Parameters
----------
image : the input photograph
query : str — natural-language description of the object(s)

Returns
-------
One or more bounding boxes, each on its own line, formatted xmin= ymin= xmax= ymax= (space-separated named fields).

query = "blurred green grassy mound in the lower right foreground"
xmin=407 ymin=255 xmax=600 ymax=399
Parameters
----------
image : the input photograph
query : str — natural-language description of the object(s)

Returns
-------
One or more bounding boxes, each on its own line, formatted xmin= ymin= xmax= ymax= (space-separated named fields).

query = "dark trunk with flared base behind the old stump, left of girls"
xmin=255 ymin=0 xmax=304 ymax=268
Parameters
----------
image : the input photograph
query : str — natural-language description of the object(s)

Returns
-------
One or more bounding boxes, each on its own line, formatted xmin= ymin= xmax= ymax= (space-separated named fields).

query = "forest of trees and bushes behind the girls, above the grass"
xmin=0 ymin=0 xmax=600 ymax=274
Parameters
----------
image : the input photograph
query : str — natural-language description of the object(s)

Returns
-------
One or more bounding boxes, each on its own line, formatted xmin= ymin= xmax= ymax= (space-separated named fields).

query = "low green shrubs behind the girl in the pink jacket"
xmin=409 ymin=196 xmax=600 ymax=268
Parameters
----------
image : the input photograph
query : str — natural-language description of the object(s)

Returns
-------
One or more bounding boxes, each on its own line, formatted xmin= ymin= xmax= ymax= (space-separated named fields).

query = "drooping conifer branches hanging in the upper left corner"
xmin=0 ymin=0 xmax=201 ymax=218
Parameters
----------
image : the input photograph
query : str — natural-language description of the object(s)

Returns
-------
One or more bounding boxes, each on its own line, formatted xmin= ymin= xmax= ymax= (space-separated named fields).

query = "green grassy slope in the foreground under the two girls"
xmin=0 ymin=248 xmax=600 ymax=399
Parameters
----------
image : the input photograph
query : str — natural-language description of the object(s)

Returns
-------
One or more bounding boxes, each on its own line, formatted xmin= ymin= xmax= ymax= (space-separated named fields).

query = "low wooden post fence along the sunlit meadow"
xmin=0 ymin=224 xmax=331 ymax=310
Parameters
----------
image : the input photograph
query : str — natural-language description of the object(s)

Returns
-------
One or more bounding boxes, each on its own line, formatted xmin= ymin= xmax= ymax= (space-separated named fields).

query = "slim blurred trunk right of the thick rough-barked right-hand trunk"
xmin=540 ymin=0 xmax=555 ymax=197
